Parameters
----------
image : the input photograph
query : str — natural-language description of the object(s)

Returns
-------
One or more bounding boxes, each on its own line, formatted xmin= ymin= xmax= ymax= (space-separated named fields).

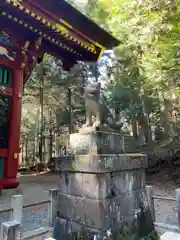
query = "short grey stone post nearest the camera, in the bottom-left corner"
xmin=1 ymin=220 xmax=20 ymax=240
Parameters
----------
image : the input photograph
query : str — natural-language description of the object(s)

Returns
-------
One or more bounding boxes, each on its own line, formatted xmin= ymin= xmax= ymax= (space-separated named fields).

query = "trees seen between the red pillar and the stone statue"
xmin=21 ymin=55 xmax=86 ymax=165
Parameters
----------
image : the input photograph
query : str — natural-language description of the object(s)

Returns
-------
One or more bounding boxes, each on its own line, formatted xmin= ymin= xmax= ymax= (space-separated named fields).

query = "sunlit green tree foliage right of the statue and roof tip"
xmin=76 ymin=0 xmax=180 ymax=146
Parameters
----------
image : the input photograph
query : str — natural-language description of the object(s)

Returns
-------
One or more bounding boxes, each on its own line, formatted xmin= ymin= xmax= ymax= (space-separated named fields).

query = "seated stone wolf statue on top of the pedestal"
xmin=84 ymin=82 xmax=123 ymax=130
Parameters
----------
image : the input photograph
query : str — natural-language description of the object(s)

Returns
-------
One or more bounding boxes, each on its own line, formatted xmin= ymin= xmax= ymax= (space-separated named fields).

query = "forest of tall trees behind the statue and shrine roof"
xmin=21 ymin=0 xmax=180 ymax=167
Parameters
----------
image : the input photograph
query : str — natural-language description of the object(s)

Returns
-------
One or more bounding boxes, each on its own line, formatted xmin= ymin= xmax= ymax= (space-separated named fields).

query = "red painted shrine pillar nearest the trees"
xmin=4 ymin=68 xmax=23 ymax=188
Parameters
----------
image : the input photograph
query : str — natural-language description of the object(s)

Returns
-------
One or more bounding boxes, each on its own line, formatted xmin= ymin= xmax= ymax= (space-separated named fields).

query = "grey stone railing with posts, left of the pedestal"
xmin=0 ymin=189 xmax=58 ymax=240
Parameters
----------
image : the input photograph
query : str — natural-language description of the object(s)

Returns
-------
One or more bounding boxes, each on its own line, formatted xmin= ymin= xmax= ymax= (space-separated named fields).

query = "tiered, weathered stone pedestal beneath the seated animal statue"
xmin=54 ymin=131 xmax=156 ymax=240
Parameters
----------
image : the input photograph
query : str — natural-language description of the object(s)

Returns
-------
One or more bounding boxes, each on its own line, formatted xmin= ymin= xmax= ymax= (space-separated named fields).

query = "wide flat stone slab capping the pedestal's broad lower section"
xmin=58 ymin=154 xmax=147 ymax=173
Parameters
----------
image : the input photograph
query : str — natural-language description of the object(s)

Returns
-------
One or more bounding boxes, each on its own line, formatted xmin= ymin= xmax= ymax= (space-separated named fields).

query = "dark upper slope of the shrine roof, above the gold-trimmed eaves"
xmin=30 ymin=0 xmax=119 ymax=49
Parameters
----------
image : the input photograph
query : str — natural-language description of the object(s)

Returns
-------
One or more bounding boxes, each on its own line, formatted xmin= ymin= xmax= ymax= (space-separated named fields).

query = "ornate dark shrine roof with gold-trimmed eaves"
xmin=0 ymin=0 xmax=119 ymax=69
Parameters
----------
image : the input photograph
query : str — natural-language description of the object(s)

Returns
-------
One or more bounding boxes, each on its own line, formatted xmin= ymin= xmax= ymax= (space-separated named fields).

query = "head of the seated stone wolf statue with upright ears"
xmin=84 ymin=82 xmax=101 ymax=100
